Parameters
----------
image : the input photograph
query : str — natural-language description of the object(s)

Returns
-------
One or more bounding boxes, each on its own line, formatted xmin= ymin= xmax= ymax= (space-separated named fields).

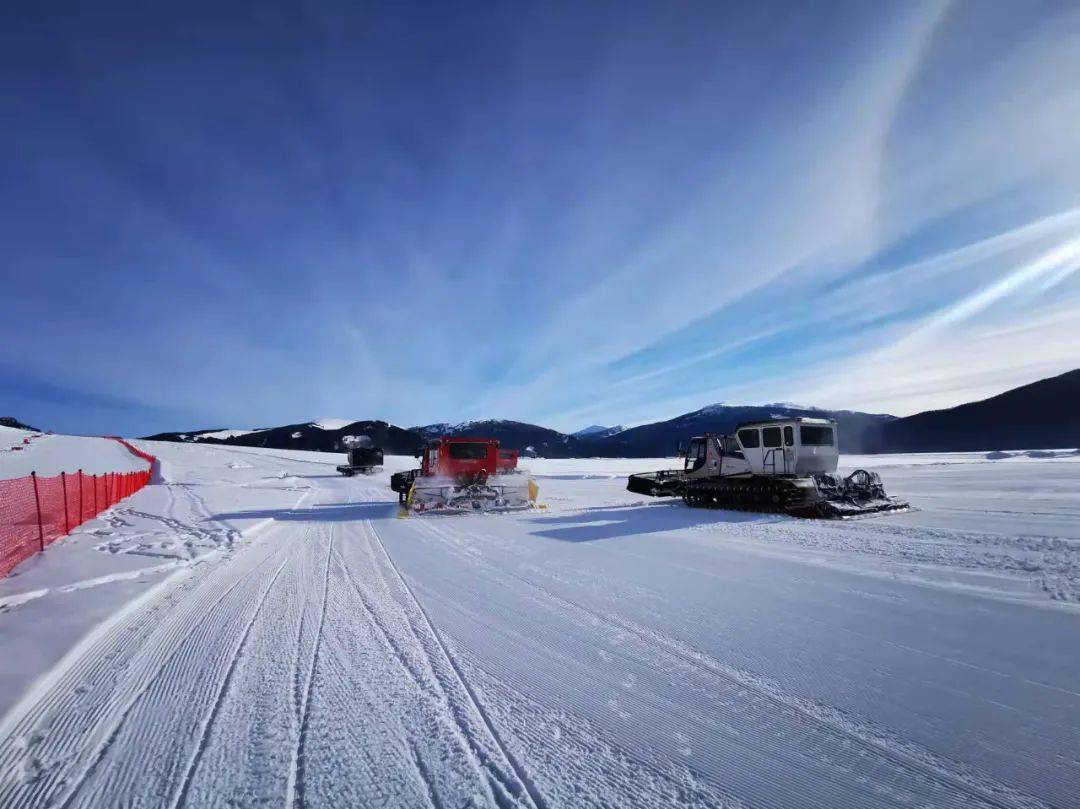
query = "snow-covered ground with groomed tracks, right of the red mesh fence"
xmin=0 ymin=442 xmax=1080 ymax=808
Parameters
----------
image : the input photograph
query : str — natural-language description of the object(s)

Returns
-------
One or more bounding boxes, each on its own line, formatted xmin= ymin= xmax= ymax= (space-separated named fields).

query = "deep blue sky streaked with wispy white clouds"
xmin=0 ymin=2 xmax=1080 ymax=434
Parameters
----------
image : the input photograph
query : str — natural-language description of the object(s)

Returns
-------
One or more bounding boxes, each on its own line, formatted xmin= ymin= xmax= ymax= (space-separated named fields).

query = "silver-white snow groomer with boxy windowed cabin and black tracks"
xmin=626 ymin=418 xmax=908 ymax=518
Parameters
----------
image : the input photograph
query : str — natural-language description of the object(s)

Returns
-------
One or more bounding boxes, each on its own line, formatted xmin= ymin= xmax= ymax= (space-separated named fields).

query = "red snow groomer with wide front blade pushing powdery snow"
xmin=390 ymin=436 xmax=539 ymax=512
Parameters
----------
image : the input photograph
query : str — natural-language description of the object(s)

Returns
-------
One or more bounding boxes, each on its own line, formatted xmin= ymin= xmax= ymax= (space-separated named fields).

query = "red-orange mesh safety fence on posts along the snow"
xmin=0 ymin=439 xmax=158 ymax=578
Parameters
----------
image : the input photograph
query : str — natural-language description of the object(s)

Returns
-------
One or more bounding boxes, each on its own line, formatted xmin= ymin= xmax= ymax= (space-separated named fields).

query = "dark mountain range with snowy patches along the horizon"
xmin=139 ymin=369 xmax=1080 ymax=458
